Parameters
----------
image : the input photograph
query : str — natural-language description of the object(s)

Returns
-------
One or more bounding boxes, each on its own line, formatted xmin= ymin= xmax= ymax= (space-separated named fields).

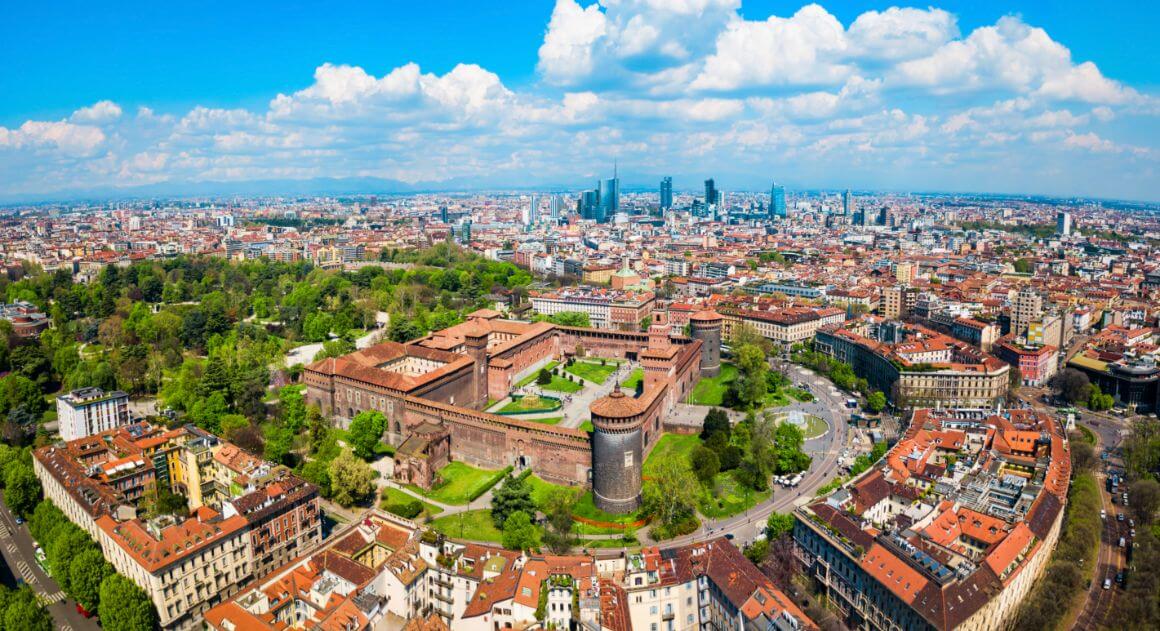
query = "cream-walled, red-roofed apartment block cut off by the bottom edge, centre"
xmin=205 ymin=510 xmax=815 ymax=631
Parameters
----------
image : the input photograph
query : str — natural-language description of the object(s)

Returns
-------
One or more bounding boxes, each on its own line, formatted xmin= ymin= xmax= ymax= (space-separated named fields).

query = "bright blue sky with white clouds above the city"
xmin=0 ymin=0 xmax=1160 ymax=201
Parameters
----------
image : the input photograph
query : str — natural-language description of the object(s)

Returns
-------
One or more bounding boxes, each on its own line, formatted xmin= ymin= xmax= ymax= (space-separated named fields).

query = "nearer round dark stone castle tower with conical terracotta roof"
xmin=588 ymin=389 xmax=644 ymax=513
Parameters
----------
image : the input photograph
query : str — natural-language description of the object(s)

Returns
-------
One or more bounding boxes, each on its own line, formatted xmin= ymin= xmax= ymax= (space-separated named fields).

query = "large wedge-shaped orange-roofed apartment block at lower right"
xmin=793 ymin=409 xmax=1071 ymax=631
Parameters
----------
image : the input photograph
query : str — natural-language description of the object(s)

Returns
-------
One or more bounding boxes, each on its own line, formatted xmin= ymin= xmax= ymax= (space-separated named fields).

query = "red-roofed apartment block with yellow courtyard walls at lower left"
xmin=32 ymin=423 xmax=321 ymax=630
